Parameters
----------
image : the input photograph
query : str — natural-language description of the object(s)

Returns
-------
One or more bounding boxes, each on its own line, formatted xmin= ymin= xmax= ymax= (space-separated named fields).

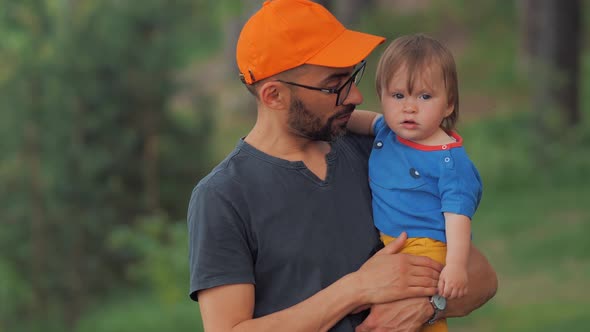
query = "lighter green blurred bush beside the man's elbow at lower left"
xmin=76 ymin=216 xmax=202 ymax=332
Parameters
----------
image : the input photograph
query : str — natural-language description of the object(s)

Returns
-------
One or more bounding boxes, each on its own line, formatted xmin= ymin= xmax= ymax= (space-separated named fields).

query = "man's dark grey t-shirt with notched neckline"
xmin=188 ymin=135 xmax=381 ymax=331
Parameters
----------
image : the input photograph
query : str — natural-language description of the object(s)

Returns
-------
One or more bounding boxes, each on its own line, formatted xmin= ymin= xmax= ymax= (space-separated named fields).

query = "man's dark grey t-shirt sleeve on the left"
xmin=187 ymin=185 xmax=255 ymax=301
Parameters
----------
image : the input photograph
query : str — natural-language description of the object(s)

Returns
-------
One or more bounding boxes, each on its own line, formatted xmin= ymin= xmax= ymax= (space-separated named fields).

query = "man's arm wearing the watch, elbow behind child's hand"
xmin=357 ymin=245 xmax=498 ymax=332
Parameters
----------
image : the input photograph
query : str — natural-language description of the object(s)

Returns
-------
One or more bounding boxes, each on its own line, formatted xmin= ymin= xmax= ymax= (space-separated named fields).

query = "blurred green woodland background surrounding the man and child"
xmin=0 ymin=0 xmax=590 ymax=332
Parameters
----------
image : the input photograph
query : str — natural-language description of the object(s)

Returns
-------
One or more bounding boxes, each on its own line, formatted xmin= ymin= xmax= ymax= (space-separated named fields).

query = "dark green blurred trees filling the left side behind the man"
xmin=0 ymin=0 xmax=212 ymax=330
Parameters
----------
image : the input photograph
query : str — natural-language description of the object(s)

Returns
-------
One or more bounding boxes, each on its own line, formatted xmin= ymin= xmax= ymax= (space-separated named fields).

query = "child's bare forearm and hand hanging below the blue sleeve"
xmin=438 ymin=212 xmax=471 ymax=299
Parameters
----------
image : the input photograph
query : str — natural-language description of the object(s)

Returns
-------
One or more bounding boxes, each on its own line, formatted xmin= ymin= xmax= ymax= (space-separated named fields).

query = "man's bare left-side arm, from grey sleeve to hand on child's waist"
xmin=198 ymin=235 xmax=442 ymax=332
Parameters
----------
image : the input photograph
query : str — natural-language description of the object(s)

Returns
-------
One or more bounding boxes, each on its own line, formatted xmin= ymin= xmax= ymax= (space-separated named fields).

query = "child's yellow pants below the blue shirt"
xmin=381 ymin=234 xmax=449 ymax=332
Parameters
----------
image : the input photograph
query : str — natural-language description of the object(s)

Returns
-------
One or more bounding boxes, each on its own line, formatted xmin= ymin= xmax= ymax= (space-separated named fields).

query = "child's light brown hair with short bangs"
xmin=375 ymin=34 xmax=459 ymax=132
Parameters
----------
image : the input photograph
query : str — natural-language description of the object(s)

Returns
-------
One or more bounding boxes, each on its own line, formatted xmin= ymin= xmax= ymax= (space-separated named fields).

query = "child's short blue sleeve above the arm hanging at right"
xmin=438 ymin=150 xmax=483 ymax=219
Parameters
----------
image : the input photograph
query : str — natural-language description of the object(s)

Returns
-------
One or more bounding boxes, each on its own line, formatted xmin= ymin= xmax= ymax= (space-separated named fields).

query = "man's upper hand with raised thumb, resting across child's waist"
xmin=355 ymin=233 xmax=443 ymax=304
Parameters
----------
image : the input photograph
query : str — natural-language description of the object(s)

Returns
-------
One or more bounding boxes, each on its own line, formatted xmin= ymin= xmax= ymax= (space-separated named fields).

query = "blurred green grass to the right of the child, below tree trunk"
xmin=450 ymin=112 xmax=590 ymax=332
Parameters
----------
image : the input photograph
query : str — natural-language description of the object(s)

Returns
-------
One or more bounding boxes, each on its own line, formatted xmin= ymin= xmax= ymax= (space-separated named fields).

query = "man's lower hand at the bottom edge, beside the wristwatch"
xmin=355 ymin=297 xmax=434 ymax=332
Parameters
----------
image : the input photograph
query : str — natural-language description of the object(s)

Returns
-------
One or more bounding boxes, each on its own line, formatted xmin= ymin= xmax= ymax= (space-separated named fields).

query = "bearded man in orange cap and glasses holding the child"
xmin=188 ymin=0 xmax=496 ymax=331
